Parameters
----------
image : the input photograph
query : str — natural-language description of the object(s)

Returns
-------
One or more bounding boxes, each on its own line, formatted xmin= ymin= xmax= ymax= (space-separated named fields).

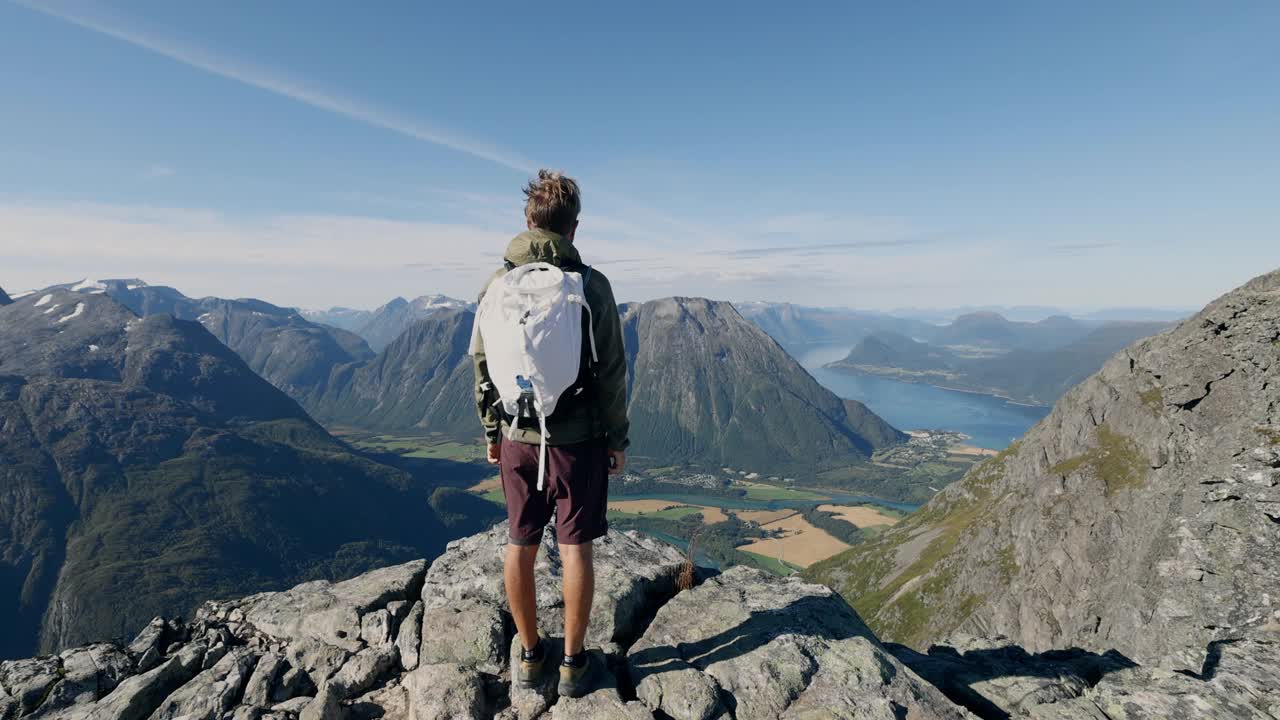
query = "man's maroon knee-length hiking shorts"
xmin=498 ymin=430 xmax=609 ymax=544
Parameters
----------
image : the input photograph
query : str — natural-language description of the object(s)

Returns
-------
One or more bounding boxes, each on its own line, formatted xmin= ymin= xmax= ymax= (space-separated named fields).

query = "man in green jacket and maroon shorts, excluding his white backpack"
xmin=474 ymin=170 xmax=628 ymax=697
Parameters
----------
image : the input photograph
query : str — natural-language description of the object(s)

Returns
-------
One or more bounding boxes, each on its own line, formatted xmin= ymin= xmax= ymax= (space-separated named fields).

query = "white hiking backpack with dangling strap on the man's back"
xmin=471 ymin=263 xmax=598 ymax=489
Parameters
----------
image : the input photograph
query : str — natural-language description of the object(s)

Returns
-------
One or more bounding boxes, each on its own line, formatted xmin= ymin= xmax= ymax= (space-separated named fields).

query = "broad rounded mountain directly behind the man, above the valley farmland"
xmin=312 ymin=297 xmax=904 ymax=473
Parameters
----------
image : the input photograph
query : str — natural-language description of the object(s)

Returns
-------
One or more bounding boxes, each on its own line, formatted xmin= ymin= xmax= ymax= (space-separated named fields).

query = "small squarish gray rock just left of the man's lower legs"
xmin=419 ymin=601 xmax=507 ymax=674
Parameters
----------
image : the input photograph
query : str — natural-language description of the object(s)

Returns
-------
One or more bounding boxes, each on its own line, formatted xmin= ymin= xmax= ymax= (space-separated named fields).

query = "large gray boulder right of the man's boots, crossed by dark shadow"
xmin=627 ymin=568 xmax=969 ymax=720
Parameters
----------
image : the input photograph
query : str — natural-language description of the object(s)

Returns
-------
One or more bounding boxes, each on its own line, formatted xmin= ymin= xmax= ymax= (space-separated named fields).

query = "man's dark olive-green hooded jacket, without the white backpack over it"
xmin=472 ymin=229 xmax=631 ymax=450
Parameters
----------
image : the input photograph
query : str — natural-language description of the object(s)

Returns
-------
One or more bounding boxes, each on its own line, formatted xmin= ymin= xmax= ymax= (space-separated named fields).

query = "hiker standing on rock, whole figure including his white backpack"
xmin=471 ymin=170 xmax=628 ymax=697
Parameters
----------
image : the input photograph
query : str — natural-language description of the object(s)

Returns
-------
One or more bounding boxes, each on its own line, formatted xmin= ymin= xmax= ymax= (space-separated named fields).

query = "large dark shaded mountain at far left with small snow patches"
xmin=0 ymin=288 xmax=493 ymax=657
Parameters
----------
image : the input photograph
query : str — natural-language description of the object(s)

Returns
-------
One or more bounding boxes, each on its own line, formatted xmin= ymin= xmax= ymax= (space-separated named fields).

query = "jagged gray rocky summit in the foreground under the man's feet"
xmin=0 ymin=525 xmax=972 ymax=720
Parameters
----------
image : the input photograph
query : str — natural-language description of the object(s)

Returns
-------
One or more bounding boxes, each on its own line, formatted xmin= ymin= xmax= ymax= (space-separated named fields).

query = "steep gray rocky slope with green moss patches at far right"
xmin=809 ymin=266 xmax=1280 ymax=674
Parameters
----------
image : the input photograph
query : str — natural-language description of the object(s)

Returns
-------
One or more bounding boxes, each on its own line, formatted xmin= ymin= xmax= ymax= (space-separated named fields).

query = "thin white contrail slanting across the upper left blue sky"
xmin=12 ymin=0 xmax=534 ymax=174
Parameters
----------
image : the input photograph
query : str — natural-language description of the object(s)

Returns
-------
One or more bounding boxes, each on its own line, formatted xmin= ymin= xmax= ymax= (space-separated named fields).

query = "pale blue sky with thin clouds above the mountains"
xmin=0 ymin=0 xmax=1280 ymax=309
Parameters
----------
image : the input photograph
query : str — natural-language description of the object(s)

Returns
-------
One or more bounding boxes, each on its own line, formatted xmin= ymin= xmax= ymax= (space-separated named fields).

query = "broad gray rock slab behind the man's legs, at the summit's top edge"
xmin=422 ymin=515 xmax=685 ymax=647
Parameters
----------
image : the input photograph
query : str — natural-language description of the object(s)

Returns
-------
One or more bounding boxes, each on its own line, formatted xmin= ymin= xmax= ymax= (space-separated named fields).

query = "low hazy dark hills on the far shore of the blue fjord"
xmin=826 ymin=320 xmax=1169 ymax=405
